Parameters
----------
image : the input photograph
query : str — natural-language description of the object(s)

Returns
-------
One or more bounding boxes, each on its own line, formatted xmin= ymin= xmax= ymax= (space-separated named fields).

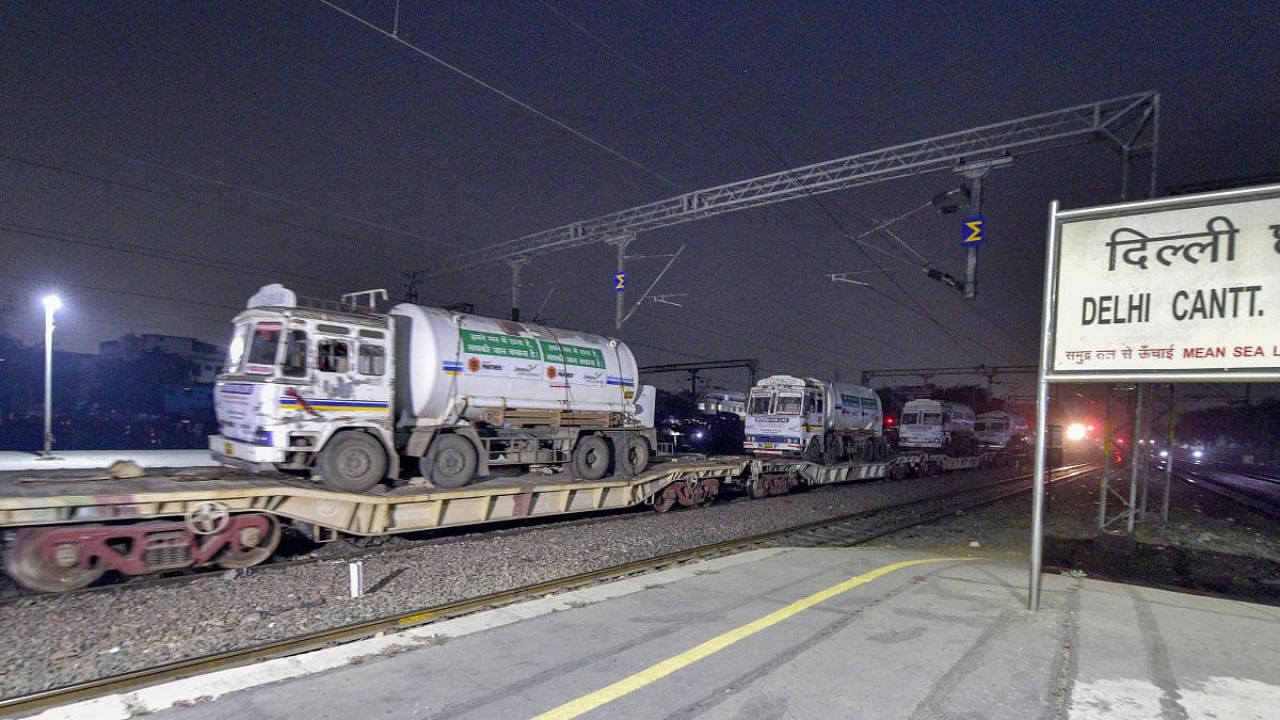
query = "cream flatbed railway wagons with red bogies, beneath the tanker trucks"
xmin=0 ymin=445 xmax=998 ymax=592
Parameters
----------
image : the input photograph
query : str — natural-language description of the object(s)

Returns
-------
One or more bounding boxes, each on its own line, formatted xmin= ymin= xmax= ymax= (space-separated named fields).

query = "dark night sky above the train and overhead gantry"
xmin=0 ymin=0 xmax=1280 ymax=387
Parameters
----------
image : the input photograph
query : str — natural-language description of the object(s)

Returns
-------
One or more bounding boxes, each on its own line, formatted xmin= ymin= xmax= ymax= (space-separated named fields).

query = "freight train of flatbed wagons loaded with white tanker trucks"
xmin=0 ymin=286 xmax=1018 ymax=592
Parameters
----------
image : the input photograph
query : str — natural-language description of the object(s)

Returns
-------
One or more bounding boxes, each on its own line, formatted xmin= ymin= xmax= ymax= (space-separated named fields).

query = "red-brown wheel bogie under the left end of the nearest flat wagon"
xmin=5 ymin=512 xmax=280 ymax=592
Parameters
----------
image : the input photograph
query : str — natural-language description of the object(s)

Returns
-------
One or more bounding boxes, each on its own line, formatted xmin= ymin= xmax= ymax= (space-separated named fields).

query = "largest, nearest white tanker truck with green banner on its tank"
xmin=210 ymin=284 xmax=658 ymax=492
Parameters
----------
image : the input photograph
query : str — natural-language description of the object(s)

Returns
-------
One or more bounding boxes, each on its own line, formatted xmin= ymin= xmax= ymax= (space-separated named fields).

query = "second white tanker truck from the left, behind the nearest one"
xmin=742 ymin=375 xmax=888 ymax=465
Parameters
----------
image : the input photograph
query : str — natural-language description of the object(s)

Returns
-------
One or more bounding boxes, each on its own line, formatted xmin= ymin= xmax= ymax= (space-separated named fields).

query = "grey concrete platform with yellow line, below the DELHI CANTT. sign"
xmin=30 ymin=548 xmax=1280 ymax=720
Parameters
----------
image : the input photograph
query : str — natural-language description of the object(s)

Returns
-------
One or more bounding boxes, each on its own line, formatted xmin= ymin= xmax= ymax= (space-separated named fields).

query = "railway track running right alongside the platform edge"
xmin=0 ymin=465 xmax=1097 ymax=717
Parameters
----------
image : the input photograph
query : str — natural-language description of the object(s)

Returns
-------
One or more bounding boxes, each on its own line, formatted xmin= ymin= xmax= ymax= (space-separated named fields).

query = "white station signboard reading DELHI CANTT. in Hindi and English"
xmin=1047 ymin=186 xmax=1280 ymax=380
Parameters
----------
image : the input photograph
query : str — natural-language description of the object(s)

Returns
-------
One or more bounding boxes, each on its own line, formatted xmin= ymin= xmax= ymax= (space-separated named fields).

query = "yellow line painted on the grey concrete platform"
xmin=534 ymin=557 xmax=973 ymax=720
